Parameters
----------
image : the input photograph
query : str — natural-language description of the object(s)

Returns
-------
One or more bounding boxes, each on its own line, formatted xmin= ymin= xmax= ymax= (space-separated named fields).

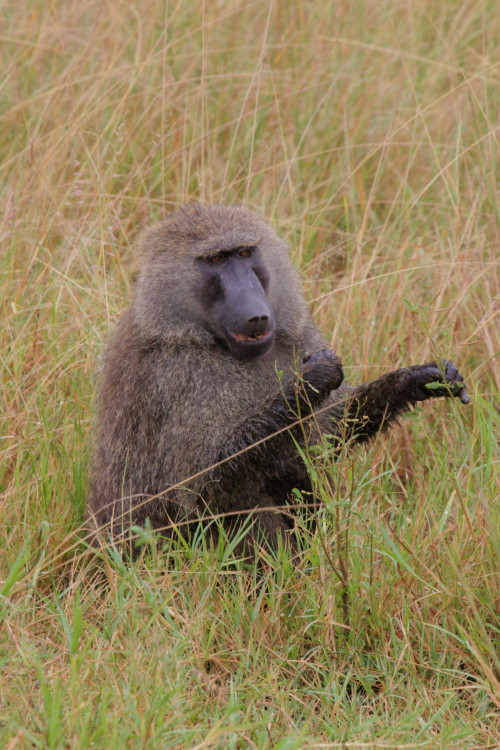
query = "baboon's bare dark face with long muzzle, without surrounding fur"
xmin=196 ymin=246 xmax=276 ymax=359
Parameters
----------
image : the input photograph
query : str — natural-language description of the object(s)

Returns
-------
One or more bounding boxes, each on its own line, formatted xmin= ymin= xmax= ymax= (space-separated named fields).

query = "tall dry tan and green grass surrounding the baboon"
xmin=0 ymin=0 xmax=500 ymax=750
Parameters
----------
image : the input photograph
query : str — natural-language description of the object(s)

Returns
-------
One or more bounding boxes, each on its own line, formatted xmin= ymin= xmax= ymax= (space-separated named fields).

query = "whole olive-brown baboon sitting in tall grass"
xmin=87 ymin=203 xmax=469 ymax=548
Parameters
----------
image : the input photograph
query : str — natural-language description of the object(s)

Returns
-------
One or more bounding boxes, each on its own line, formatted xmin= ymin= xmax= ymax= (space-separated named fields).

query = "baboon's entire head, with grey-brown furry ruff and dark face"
xmin=133 ymin=203 xmax=307 ymax=360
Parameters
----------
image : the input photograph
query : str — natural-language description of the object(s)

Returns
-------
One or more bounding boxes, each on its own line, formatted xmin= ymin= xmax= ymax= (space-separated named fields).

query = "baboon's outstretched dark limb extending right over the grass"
xmin=334 ymin=360 xmax=469 ymax=441
